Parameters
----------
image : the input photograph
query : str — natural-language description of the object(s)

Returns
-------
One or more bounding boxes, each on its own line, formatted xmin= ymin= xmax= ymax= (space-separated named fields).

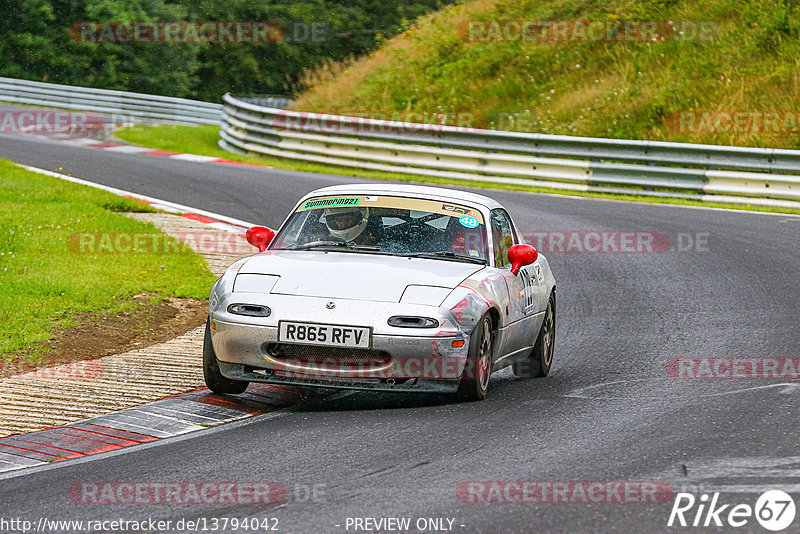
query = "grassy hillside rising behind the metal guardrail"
xmin=294 ymin=0 xmax=800 ymax=148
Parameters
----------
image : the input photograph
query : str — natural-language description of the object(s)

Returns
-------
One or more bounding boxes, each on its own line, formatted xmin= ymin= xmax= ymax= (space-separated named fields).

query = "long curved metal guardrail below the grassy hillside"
xmin=219 ymin=94 xmax=800 ymax=207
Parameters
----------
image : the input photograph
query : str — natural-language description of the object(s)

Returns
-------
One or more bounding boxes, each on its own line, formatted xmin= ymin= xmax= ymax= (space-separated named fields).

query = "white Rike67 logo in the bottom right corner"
xmin=667 ymin=490 xmax=796 ymax=532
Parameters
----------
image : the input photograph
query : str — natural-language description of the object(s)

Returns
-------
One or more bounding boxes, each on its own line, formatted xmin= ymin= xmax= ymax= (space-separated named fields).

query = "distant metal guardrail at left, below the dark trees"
xmin=0 ymin=77 xmax=222 ymax=124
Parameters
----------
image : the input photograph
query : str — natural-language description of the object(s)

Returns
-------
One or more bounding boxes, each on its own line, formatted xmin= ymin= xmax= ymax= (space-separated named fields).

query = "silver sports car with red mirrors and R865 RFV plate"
xmin=203 ymin=184 xmax=556 ymax=400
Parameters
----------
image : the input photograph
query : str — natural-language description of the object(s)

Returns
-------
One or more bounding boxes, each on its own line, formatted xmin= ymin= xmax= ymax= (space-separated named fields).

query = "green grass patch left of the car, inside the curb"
xmin=0 ymin=160 xmax=214 ymax=363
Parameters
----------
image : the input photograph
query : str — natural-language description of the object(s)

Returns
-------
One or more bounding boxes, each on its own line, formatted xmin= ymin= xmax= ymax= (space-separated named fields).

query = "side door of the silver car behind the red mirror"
xmin=491 ymin=208 xmax=544 ymax=357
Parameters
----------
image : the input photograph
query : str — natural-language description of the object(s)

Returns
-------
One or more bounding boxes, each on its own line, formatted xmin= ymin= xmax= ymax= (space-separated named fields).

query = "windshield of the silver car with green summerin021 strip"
xmin=270 ymin=195 xmax=487 ymax=263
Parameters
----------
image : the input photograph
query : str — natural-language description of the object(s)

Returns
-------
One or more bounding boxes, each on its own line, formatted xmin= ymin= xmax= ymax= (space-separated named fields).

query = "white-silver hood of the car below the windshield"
xmin=239 ymin=251 xmax=484 ymax=302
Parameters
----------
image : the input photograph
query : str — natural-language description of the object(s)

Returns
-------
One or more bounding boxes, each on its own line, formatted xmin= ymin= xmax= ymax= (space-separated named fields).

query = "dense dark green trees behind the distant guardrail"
xmin=0 ymin=0 xmax=446 ymax=101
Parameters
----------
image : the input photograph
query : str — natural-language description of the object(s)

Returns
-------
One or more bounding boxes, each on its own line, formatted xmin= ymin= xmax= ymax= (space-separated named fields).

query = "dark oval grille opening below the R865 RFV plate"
xmin=265 ymin=343 xmax=391 ymax=371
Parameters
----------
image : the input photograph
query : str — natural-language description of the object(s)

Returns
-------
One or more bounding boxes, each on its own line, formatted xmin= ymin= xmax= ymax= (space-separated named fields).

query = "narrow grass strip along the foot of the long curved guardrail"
xmin=116 ymin=126 xmax=800 ymax=214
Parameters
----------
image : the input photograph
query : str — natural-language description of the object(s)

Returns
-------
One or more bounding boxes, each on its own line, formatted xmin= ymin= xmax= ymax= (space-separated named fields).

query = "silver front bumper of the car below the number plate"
xmin=211 ymin=318 xmax=469 ymax=392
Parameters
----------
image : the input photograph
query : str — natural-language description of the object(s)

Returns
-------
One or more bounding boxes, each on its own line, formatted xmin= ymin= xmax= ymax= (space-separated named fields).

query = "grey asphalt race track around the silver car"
xmin=0 ymin=131 xmax=800 ymax=533
